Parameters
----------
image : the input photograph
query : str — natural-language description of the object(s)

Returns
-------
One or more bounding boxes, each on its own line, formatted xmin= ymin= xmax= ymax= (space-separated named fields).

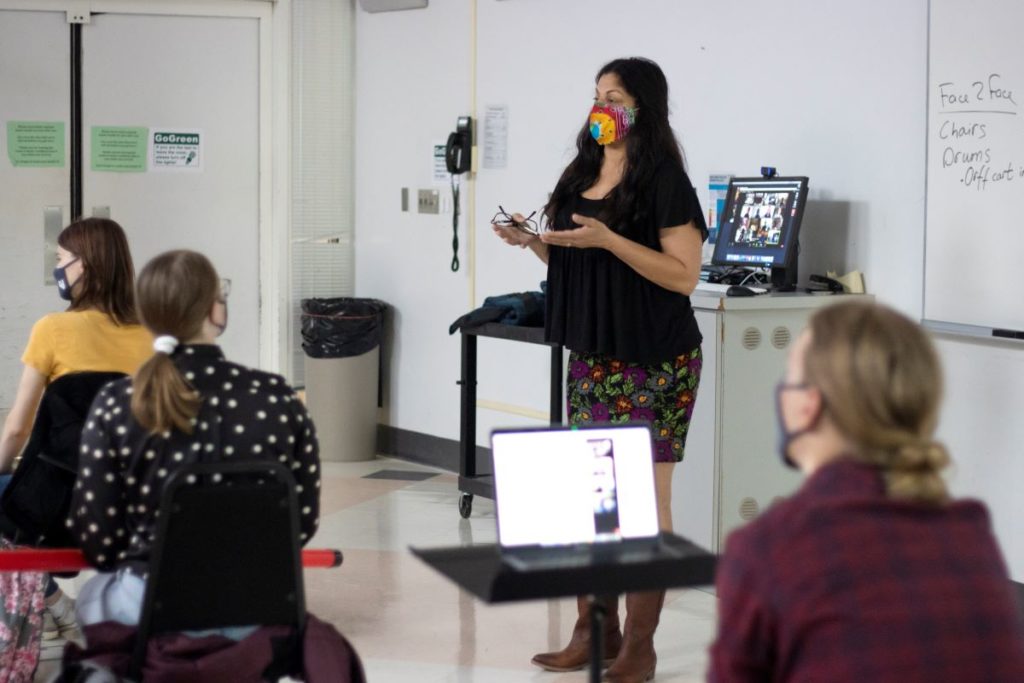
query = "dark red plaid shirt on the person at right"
xmin=709 ymin=460 xmax=1024 ymax=683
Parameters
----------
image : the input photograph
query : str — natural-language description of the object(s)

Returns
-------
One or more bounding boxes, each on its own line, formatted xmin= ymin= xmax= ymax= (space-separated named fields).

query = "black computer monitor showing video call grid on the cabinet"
xmin=712 ymin=176 xmax=807 ymax=291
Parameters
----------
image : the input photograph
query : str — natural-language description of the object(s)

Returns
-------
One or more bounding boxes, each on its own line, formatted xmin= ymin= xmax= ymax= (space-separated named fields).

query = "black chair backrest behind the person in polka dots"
xmin=133 ymin=461 xmax=305 ymax=671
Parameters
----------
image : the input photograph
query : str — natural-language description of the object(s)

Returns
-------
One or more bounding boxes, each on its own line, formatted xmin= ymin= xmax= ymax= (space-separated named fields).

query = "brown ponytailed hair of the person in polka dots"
xmin=131 ymin=250 xmax=220 ymax=434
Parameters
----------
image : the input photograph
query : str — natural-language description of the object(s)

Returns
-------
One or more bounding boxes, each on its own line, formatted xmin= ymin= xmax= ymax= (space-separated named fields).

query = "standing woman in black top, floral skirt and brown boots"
xmin=493 ymin=57 xmax=708 ymax=682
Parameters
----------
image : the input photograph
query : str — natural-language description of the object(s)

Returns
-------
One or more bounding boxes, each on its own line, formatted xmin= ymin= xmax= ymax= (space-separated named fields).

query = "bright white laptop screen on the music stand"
xmin=490 ymin=425 xmax=658 ymax=547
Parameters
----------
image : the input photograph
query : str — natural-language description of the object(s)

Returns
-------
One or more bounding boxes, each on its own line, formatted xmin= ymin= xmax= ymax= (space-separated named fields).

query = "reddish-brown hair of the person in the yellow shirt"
xmin=57 ymin=218 xmax=138 ymax=325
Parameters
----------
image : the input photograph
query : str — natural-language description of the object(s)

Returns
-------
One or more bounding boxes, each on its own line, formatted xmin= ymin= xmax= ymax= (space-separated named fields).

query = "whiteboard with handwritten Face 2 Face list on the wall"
xmin=924 ymin=0 xmax=1024 ymax=336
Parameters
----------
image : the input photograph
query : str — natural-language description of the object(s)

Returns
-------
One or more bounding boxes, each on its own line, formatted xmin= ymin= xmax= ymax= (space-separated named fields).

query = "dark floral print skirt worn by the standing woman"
xmin=566 ymin=346 xmax=702 ymax=463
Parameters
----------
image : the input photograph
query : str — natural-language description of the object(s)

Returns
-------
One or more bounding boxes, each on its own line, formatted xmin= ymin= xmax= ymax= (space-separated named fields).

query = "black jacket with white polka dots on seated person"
xmin=68 ymin=345 xmax=321 ymax=575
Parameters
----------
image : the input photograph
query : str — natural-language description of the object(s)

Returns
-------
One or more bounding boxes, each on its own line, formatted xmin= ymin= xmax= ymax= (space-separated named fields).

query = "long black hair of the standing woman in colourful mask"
xmin=544 ymin=57 xmax=685 ymax=231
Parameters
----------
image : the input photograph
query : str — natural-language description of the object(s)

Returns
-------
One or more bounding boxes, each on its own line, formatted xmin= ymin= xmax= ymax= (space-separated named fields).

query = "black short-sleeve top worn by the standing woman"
xmin=546 ymin=162 xmax=708 ymax=364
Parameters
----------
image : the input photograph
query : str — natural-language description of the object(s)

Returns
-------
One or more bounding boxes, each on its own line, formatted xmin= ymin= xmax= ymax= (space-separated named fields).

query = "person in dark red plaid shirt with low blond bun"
xmin=709 ymin=303 xmax=1024 ymax=683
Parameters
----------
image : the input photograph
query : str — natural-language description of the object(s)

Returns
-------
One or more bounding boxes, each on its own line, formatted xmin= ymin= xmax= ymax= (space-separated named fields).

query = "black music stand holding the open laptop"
xmin=410 ymin=532 xmax=717 ymax=683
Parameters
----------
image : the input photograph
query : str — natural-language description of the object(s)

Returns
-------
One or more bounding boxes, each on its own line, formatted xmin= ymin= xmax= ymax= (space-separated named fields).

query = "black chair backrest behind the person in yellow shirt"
xmin=0 ymin=372 xmax=125 ymax=548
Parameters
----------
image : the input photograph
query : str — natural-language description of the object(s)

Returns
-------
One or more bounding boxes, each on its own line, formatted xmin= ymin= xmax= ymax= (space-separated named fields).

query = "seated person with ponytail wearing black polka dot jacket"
xmin=70 ymin=251 xmax=319 ymax=635
